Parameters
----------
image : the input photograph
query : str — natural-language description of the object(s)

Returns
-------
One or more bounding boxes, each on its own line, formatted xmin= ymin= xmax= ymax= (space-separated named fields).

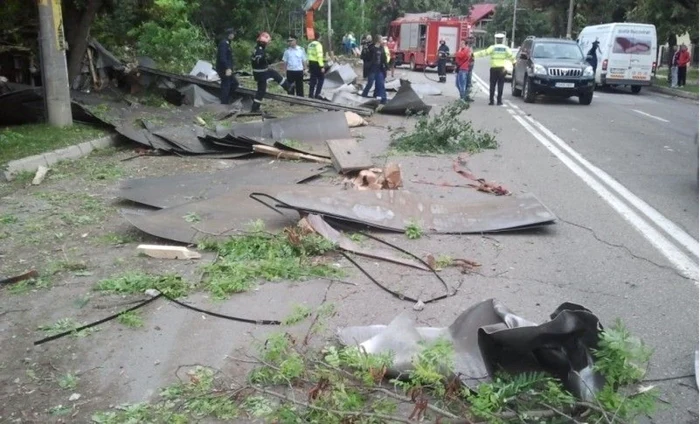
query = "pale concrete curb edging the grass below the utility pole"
xmin=2 ymin=134 xmax=121 ymax=181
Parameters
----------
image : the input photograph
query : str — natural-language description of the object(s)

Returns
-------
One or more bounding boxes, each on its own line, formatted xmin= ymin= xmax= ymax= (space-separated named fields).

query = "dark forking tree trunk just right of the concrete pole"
xmin=63 ymin=0 xmax=104 ymax=83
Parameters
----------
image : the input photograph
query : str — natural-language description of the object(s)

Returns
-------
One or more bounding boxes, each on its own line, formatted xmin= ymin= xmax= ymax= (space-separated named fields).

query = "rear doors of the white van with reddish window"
xmin=607 ymin=25 xmax=656 ymax=85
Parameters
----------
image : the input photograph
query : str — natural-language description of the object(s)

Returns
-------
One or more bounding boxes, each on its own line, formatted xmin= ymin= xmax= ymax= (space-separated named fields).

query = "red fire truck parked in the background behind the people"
xmin=389 ymin=12 xmax=471 ymax=71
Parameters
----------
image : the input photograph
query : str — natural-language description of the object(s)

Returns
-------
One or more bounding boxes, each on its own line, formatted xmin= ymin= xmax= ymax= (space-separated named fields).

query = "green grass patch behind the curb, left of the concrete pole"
xmin=0 ymin=124 xmax=107 ymax=165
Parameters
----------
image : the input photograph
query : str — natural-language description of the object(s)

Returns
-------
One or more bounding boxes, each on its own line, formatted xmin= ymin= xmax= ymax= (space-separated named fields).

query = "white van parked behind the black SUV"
xmin=578 ymin=23 xmax=657 ymax=94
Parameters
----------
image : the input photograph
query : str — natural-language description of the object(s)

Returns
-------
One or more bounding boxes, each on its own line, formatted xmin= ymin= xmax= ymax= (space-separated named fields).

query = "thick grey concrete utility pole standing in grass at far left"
xmin=37 ymin=0 xmax=73 ymax=127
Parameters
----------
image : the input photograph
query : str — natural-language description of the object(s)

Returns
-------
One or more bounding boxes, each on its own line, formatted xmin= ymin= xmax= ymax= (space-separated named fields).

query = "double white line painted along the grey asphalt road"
xmin=474 ymin=75 xmax=698 ymax=278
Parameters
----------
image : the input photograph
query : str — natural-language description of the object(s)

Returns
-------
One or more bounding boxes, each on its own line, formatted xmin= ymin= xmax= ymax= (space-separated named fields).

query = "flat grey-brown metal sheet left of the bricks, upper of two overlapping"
xmin=117 ymin=159 xmax=326 ymax=208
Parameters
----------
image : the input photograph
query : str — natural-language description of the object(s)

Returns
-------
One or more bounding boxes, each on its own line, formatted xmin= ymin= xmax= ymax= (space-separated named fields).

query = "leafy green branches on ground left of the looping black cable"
xmin=199 ymin=229 xmax=342 ymax=299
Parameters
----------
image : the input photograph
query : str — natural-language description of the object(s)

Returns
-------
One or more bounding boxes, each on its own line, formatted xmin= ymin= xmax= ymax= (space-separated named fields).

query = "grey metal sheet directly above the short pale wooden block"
xmin=122 ymin=186 xmax=298 ymax=243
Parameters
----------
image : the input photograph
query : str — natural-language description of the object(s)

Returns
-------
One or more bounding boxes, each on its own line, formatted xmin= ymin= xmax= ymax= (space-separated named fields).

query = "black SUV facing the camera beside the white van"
xmin=511 ymin=37 xmax=595 ymax=105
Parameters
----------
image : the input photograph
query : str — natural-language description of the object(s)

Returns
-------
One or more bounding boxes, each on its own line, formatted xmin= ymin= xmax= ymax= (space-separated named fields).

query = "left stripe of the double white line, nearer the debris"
xmin=508 ymin=109 xmax=698 ymax=281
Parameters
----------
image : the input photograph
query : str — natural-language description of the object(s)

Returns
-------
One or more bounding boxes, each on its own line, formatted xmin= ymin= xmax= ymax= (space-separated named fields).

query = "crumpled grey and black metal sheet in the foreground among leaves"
xmin=337 ymin=299 xmax=604 ymax=400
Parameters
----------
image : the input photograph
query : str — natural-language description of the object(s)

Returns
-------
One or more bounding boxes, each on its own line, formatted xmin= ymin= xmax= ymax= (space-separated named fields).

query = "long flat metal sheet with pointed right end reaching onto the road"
xmin=263 ymin=186 xmax=556 ymax=234
